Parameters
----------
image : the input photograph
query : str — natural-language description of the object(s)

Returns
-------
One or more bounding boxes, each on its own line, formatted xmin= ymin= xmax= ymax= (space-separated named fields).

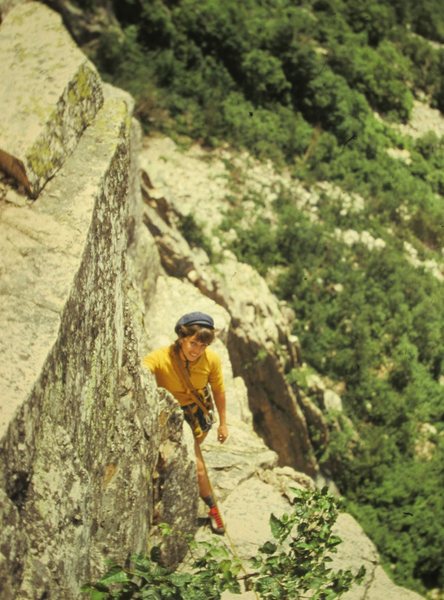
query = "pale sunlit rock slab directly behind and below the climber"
xmin=146 ymin=276 xmax=420 ymax=600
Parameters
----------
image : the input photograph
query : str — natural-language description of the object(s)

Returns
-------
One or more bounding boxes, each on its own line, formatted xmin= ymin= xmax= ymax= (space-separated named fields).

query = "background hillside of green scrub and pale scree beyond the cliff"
xmin=3 ymin=0 xmax=444 ymax=600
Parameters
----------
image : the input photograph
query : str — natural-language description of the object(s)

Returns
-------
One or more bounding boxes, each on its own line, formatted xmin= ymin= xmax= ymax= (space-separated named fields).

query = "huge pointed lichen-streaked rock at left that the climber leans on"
xmin=0 ymin=4 xmax=197 ymax=600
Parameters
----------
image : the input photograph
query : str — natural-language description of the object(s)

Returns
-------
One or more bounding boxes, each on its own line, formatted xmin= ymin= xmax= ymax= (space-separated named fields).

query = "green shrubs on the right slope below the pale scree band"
xmin=227 ymin=184 xmax=444 ymax=592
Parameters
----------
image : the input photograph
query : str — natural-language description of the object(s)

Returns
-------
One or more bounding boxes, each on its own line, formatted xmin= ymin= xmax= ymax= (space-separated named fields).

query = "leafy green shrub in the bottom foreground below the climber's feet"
xmin=82 ymin=488 xmax=365 ymax=600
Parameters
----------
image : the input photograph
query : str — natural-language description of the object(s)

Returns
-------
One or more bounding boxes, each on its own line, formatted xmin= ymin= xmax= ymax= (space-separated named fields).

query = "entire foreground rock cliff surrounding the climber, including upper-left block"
xmin=0 ymin=2 xmax=420 ymax=600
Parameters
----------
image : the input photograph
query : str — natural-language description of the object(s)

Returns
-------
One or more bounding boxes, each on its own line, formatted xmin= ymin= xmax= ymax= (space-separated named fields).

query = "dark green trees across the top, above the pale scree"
xmin=87 ymin=0 xmax=444 ymax=176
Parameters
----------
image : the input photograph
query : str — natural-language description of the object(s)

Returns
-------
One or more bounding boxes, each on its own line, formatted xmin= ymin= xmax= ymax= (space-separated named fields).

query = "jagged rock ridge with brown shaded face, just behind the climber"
xmin=141 ymin=138 xmax=328 ymax=475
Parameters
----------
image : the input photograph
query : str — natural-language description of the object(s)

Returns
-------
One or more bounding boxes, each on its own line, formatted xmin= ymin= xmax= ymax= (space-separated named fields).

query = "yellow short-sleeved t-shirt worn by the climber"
xmin=142 ymin=346 xmax=224 ymax=406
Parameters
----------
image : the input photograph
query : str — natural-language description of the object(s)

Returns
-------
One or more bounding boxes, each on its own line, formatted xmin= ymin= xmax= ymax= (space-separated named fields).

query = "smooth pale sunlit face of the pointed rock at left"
xmin=0 ymin=84 xmax=129 ymax=436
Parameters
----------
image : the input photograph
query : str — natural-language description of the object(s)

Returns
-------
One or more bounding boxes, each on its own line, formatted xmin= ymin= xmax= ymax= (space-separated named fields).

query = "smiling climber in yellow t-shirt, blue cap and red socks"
xmin=143 ymin=312 xmax=228 ymax=534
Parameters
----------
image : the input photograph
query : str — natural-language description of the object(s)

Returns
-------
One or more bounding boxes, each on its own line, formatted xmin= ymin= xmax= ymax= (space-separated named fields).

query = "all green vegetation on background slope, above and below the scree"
xmin=74 ymin=0 xmax=444 ymax=592
